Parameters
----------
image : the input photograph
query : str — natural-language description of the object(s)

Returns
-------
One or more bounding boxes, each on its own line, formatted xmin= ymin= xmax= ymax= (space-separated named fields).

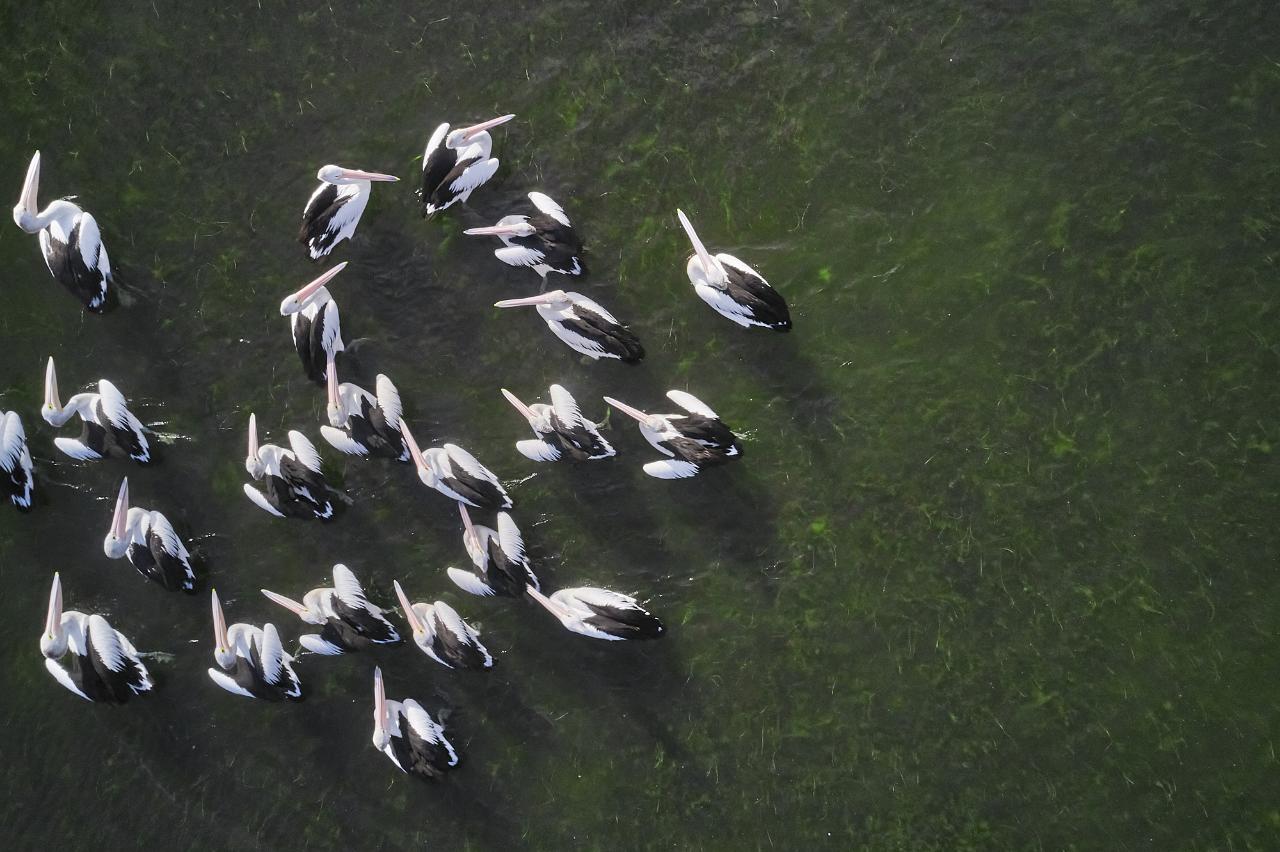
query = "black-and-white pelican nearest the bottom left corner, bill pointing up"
xmin=40 ymin=573 xmax=155 ymax=704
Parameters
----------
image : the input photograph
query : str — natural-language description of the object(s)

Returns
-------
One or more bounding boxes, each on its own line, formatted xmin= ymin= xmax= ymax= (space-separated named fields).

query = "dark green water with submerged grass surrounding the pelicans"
xmin=0 ymin=0 xmax=1280 ymax=849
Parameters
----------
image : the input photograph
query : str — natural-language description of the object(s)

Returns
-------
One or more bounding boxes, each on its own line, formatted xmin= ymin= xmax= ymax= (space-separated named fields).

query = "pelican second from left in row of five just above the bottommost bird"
xmin=209 ymin=590 xmax=302 ymax=701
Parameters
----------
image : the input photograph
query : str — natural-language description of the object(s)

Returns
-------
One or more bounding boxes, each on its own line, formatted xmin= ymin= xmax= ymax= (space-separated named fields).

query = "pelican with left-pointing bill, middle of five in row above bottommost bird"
xmin=262 ymin=563 xmax=401 ymax=656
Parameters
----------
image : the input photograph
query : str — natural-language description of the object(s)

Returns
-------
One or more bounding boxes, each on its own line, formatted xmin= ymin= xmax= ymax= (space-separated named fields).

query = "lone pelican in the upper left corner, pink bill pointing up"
xmin=13 ymin=151 xmax=116 ymax=313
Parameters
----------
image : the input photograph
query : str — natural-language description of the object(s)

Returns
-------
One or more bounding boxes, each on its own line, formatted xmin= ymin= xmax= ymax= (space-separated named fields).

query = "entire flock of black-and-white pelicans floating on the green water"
xmin=0 ymin=115 xmax=791 ymax=778
